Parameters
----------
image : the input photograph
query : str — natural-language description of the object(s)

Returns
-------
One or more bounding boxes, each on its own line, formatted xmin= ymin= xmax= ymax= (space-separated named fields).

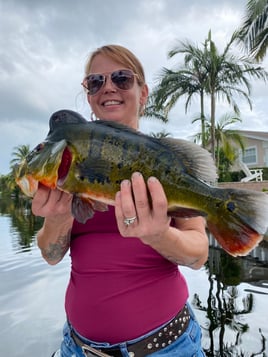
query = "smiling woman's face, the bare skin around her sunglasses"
xmin=87 ymin=55 xmax=148 ymax=129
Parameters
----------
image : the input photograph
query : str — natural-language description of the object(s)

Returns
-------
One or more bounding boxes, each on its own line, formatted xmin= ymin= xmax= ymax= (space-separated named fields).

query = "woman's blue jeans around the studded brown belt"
xmin=61 ymin=305 xmax=205 ymax=357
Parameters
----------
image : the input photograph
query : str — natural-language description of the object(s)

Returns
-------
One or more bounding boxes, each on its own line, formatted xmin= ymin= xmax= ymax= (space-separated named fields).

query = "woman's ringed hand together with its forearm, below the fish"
xmin=115 ymin=172 xmax=208 ymax=269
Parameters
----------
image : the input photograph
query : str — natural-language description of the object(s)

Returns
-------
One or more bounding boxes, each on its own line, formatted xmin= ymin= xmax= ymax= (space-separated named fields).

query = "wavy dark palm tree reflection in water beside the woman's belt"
xmin=192 ymin=266 xmax=266 ymax=356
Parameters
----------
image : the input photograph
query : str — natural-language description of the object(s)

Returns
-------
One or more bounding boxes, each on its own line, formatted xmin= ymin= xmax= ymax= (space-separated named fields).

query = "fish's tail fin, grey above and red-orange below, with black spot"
xmin=207 ymin=189 xmax=268 ymax=256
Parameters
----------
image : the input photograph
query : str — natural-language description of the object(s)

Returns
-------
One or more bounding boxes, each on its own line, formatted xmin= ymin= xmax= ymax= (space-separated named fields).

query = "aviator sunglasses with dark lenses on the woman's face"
xmin=81 ymin=69 xmax=137 ymax=95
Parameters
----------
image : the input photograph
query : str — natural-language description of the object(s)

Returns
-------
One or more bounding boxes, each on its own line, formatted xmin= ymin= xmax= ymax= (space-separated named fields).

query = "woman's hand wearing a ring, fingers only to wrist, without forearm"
xmin=115 ymin=172 xmax=170 ymax=245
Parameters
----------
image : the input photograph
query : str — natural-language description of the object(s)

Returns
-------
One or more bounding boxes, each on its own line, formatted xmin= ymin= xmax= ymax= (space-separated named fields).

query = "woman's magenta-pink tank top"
xmin=65 ymin=207 xmax=188 ymax=343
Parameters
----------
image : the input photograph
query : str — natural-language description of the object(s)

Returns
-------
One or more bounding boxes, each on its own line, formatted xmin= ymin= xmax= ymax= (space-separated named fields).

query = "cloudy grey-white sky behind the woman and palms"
xmin=0 ymin=0 xmax=268 ymax=175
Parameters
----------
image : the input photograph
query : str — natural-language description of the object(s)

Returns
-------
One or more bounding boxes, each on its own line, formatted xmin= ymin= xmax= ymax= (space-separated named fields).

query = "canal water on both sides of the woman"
xmin=0 ymin=200 xmax=268 ymax=357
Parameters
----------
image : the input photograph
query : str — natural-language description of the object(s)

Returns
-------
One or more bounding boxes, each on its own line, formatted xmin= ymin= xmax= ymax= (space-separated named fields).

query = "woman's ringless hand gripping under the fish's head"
xmin=32 ymin=184 xmax=73 ymax=218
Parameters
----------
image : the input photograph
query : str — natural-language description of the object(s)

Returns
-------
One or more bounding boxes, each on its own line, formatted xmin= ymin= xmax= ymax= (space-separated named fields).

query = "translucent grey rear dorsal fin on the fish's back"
xmin=157 ymin=138 xmax=218 ymax=183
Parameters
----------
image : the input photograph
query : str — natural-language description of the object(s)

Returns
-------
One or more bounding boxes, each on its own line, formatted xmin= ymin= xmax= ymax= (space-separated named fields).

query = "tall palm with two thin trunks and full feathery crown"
xmin=152 ymin=31 xmax=268 ymax=159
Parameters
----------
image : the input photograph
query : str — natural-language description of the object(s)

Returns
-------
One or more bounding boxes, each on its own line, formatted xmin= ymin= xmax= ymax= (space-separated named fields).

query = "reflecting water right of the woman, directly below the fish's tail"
xmin=188 ymin=237 xmax=268 ymax=357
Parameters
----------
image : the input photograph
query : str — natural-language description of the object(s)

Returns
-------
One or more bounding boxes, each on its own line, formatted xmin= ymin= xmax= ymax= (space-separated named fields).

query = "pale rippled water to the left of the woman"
xmin=0 ymin=210 xmax=70 ymax=357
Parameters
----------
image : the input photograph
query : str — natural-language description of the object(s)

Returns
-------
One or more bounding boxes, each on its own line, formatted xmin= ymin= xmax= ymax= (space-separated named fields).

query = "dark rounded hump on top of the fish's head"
xmin=48 ymin=109 xmax=88 ymax=135
